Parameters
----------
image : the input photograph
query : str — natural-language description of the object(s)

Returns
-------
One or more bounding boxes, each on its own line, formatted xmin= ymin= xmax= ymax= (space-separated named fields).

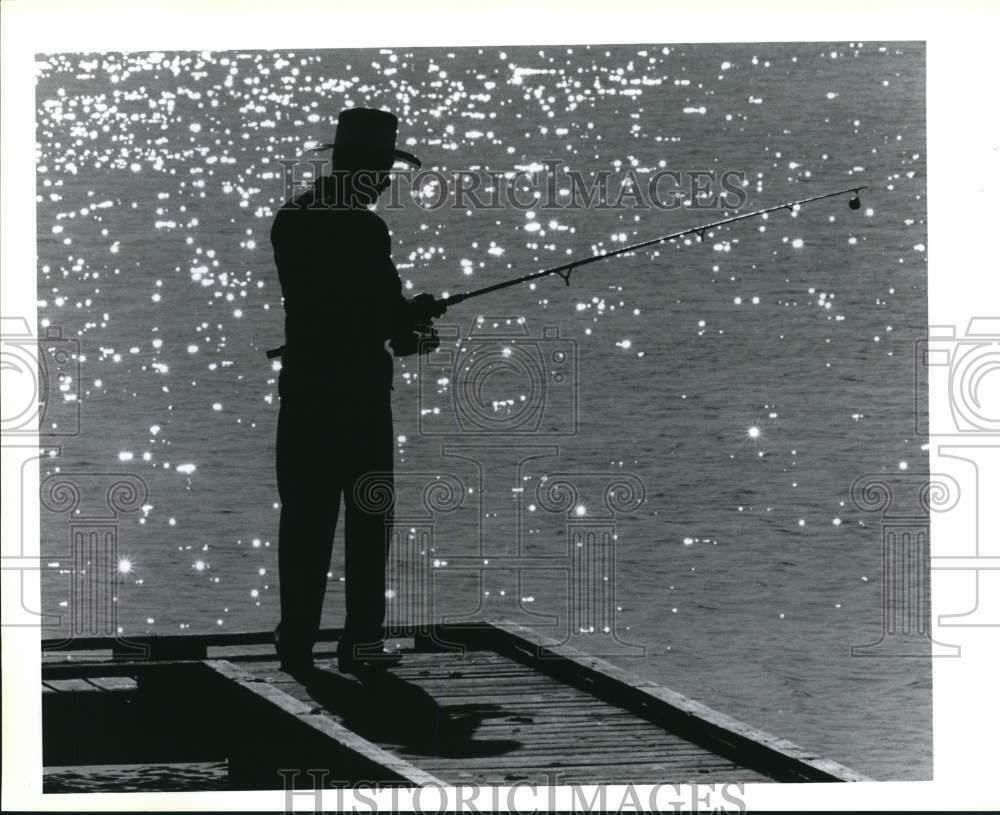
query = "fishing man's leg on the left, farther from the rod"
xmin=276 ymin=398 xmax=340 ymax=656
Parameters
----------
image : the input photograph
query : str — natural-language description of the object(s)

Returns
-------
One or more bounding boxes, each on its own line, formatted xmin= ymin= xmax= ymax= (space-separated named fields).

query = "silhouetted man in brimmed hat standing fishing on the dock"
xmin=271 ymin=108 xmax=444 ymax=672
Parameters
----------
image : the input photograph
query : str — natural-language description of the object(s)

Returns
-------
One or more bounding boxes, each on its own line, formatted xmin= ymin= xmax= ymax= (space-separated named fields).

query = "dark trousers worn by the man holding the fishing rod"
xmin=276 ymin=386 xmax=395 ymax=649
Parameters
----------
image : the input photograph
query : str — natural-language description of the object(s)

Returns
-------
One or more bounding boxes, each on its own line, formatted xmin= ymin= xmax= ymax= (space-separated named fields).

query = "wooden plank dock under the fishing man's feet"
xmin=42 ymin=621 xmax=870 ymax=792
